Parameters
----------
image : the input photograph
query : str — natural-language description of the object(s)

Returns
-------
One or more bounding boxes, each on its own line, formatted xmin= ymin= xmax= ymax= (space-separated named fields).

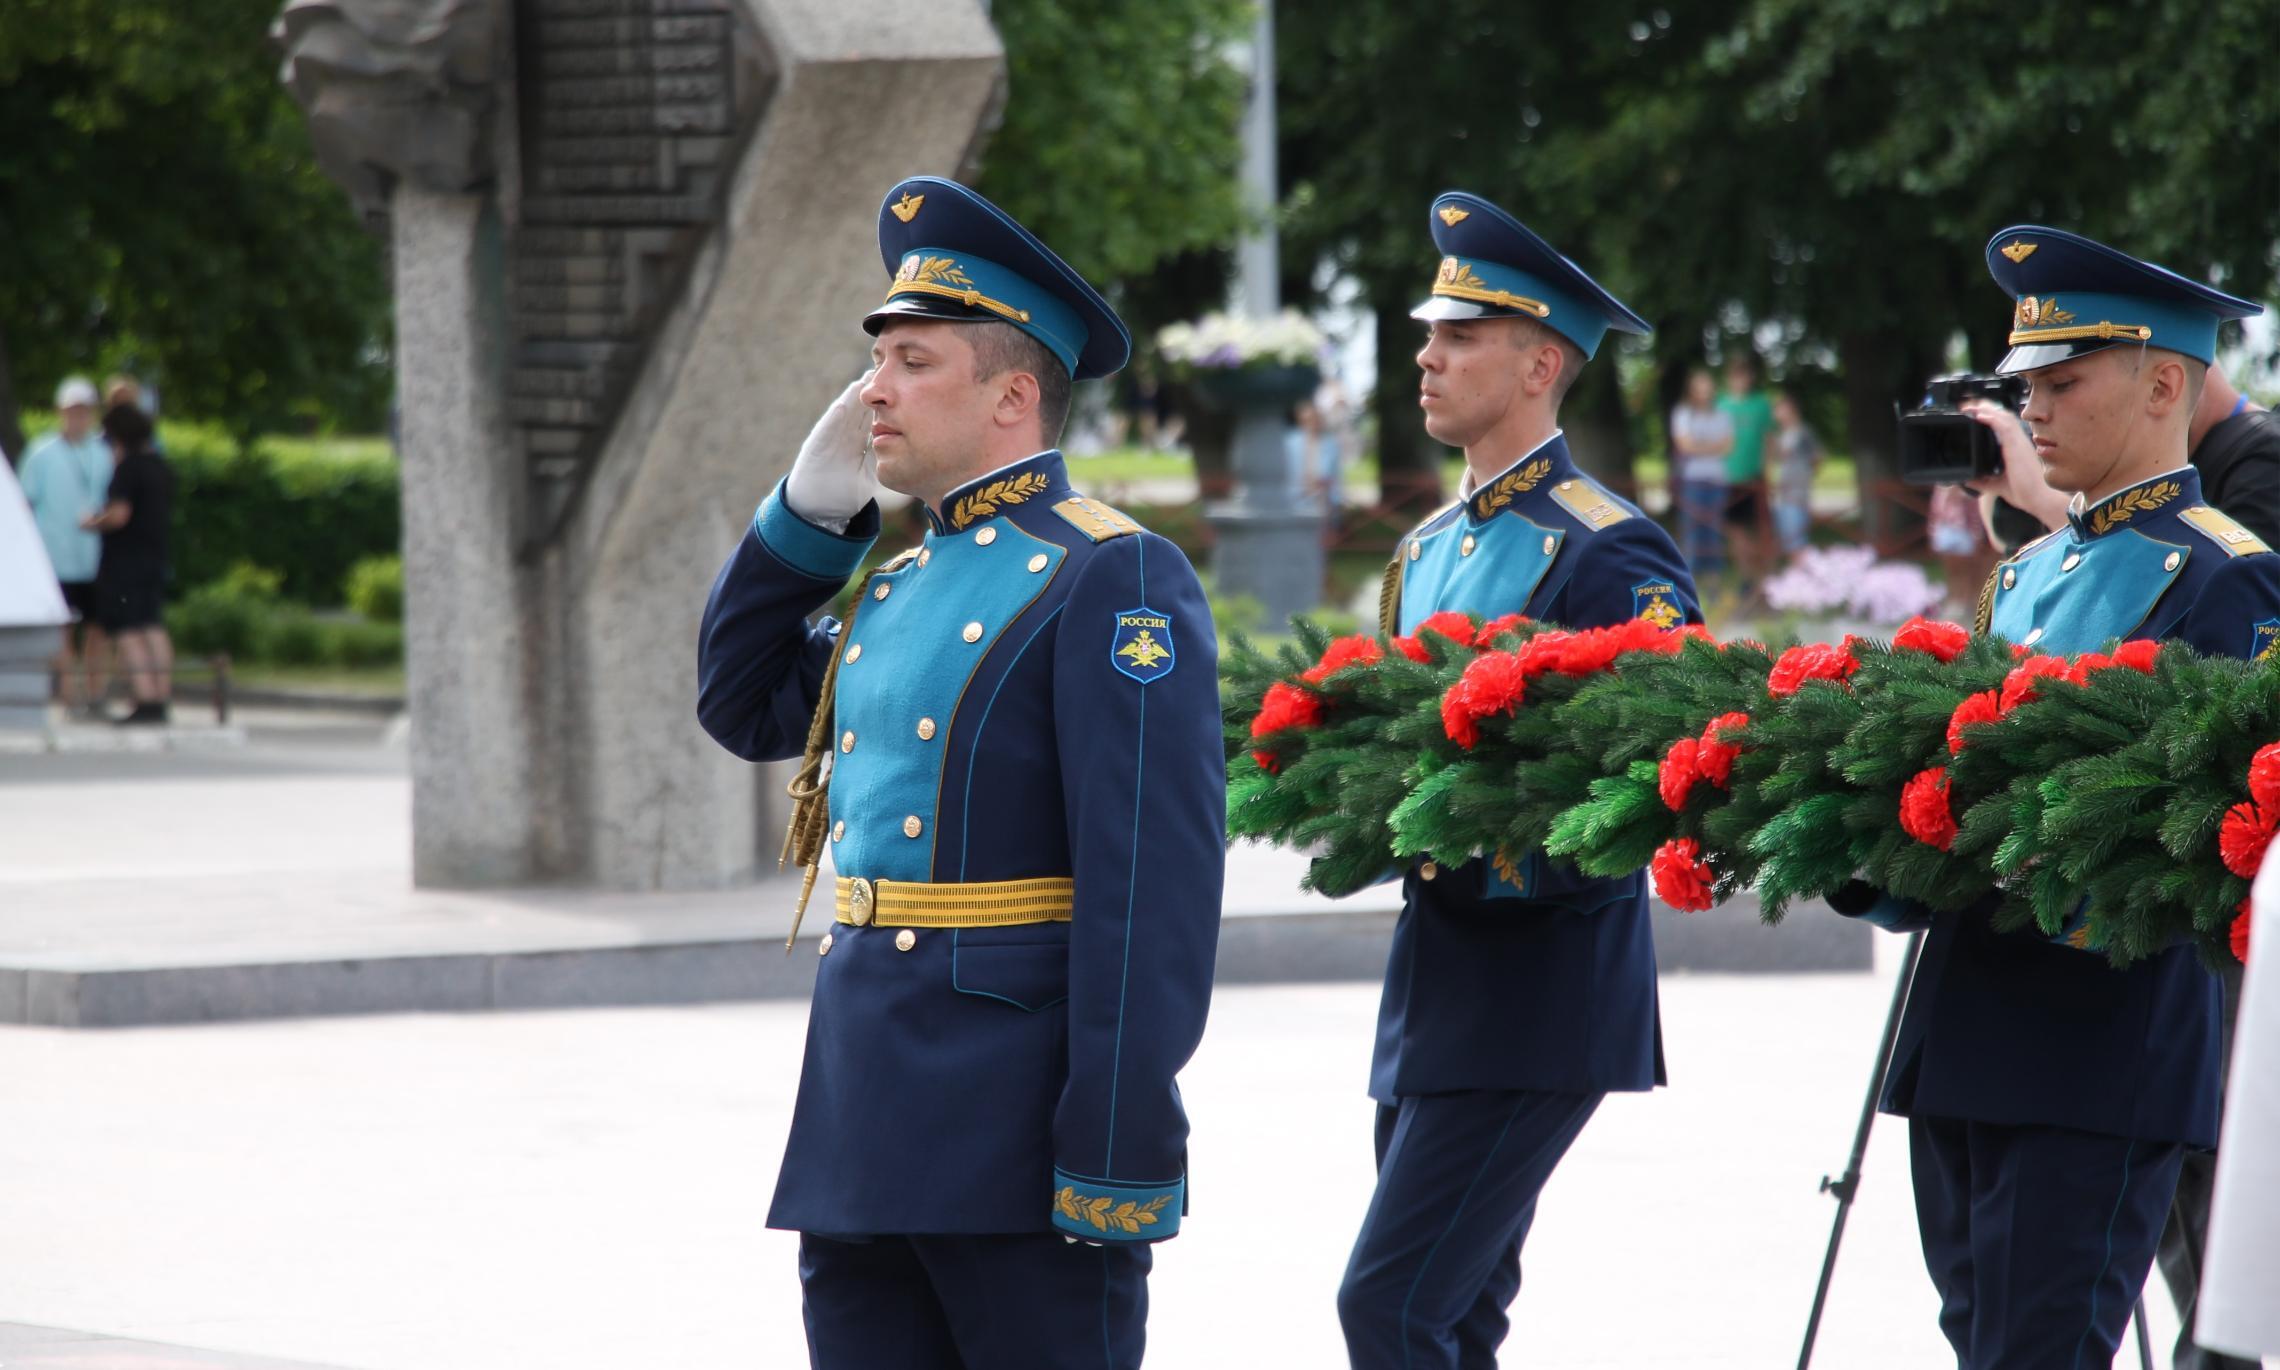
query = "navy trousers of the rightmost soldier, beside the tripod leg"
xmin=1908 ymin=1119 xmax=2184 ymax=1370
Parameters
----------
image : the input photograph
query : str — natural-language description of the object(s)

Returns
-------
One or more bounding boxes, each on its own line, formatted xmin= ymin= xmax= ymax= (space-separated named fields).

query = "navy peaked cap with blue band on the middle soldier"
xmin=1409 ymin=189 xmax=1653 ymax=358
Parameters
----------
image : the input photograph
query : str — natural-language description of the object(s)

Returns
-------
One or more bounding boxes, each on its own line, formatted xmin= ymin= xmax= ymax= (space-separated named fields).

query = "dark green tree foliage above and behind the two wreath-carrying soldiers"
xmin=1279 ymin=0 xmax=2280 ymax=508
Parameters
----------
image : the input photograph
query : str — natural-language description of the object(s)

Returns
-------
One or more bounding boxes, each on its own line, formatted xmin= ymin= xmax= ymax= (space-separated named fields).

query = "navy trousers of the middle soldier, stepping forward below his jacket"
xmin=1338 ymin=1090 xmax=1605 ymax=1370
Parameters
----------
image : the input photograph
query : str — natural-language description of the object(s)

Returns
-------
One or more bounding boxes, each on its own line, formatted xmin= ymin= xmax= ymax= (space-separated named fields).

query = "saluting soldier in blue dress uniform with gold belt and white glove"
xmin=698 ymin=176 xmax=1227 ymax=1370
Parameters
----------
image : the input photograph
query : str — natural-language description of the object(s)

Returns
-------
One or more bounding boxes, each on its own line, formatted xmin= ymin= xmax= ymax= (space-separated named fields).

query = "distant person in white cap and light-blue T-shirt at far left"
xmin=18 ymin=376 xmax=112 ymax=711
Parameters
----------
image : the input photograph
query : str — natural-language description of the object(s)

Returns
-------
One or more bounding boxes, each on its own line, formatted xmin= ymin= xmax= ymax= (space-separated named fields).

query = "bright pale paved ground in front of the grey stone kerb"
xmin=0 ymin=973 xmax=2168 ymax=1370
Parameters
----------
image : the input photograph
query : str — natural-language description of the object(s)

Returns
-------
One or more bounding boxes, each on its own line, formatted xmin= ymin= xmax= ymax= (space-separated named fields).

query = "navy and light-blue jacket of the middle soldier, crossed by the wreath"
xmin=1370 ymin=433 xmax=1701 ymax=1103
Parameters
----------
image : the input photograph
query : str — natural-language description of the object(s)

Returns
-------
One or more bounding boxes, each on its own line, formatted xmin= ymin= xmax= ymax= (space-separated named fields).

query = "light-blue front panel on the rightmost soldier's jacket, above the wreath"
xmin=1988 ymin=529 xmax=2193 ymax=657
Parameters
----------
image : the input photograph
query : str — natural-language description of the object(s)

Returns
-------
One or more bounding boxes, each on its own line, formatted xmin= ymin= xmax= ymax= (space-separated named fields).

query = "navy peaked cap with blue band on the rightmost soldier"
xmin=1988 ymin=223 xmax=2264 ymax=376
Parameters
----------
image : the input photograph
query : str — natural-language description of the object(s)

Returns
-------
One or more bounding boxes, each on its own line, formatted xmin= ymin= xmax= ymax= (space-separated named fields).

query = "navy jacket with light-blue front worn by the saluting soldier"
xmin=698 ymin=451 xmax=1227 ymax=1240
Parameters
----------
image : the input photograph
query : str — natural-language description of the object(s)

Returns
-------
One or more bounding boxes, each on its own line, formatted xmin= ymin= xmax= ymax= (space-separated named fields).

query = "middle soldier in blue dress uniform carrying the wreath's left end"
xmin=1338 ymin=191 xmax=1701 ymax=1370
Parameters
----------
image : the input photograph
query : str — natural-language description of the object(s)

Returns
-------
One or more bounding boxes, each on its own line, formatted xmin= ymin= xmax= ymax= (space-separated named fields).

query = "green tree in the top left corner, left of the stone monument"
xmin=0 ymin=0 xmax=388 ymax=451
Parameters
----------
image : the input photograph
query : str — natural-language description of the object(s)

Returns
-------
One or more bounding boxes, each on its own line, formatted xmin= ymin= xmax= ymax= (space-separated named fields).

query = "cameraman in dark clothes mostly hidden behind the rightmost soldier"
xmin=1961 ymin=362 xmax=2280 ymax=1370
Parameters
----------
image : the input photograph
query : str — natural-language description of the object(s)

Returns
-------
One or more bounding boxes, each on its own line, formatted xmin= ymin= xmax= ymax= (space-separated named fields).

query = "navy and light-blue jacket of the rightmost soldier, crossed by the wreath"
xmin=1831 ymin=467 xmax=2280 ymax=1147
